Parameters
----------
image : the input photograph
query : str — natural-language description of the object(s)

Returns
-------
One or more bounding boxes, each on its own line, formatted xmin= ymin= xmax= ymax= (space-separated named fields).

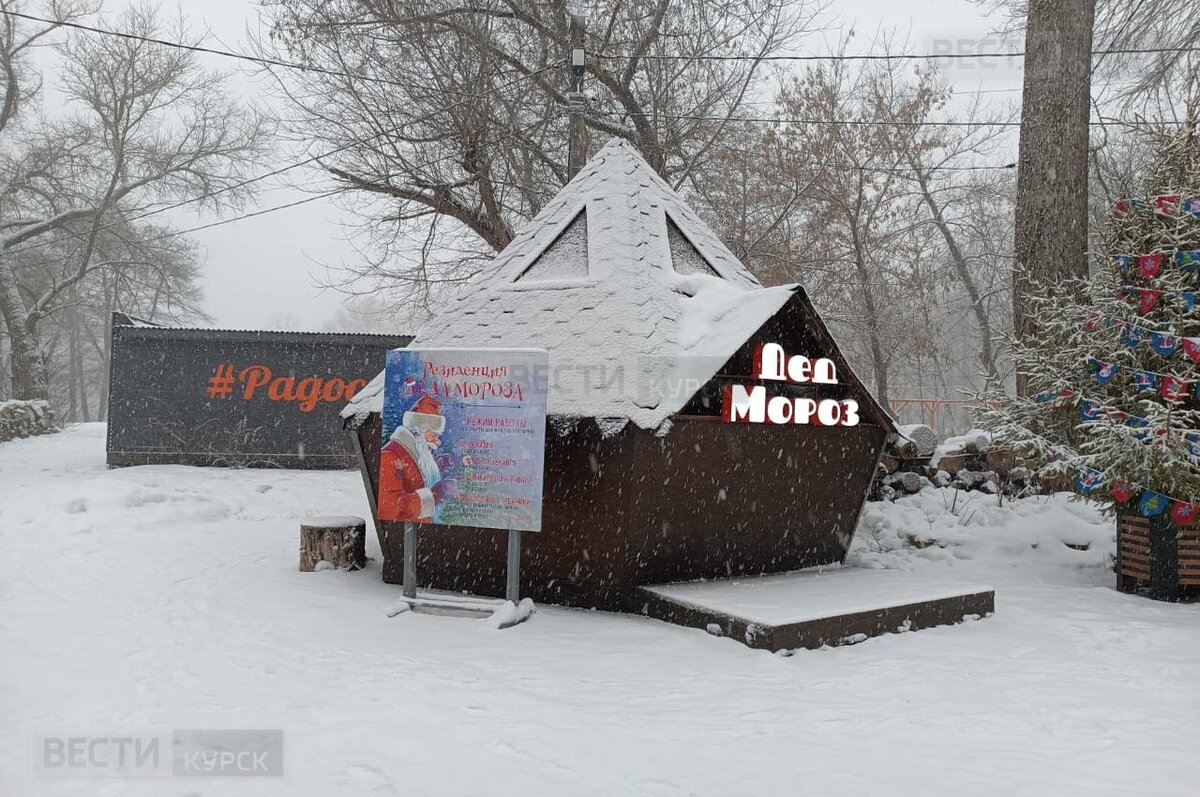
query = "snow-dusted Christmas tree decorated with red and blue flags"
xmin=979 ymin=112 xmax=1200 ymax=532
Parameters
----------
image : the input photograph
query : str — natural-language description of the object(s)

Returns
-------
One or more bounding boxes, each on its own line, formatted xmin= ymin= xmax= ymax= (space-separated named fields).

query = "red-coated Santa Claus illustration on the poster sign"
xmin=379 ymin=396 xmax=457 ymax=523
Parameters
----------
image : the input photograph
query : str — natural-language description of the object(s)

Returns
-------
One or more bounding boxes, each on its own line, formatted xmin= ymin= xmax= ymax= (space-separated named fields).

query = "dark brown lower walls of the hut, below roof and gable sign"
xmin=359 ymin=417 xmax=886 ymax=611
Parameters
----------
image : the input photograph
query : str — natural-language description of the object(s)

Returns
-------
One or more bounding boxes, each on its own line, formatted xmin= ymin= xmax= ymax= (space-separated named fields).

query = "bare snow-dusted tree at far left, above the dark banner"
xmin=0 ymin=7 xmax=266 ymax=399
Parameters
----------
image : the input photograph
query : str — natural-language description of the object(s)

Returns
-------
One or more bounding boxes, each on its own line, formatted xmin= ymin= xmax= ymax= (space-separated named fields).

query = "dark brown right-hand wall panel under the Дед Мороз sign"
xmin=626 ymin=419 xmax=884 ymax=585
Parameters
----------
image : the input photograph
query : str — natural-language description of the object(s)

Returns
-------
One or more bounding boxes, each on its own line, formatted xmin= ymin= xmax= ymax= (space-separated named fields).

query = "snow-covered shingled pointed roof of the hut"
xmin=342 ymin=139 xmax=796 ymax=429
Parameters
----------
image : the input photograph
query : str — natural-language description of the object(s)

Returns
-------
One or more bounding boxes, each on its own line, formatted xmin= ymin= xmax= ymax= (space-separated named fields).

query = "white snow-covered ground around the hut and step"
xmin=0 ymin=425 xmax=1200 ymax=797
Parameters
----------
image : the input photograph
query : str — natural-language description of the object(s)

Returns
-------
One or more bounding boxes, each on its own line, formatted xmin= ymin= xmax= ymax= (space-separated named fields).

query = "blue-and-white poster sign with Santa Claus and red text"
xmin=378 ymin=348 xmax=548 ymax=532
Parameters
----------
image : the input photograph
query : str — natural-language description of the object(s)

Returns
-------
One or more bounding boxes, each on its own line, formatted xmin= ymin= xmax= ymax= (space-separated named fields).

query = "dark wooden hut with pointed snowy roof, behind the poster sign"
xmin=343 ymin=140 xmax=895 ymax=611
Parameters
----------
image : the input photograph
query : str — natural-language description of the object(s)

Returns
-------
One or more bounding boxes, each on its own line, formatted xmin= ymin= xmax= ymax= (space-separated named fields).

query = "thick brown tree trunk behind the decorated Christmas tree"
xmin=1013 ymin=0 xmax=1096 ymax=392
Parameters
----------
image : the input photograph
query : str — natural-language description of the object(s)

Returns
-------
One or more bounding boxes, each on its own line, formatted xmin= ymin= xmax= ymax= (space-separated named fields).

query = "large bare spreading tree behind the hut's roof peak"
xmin=266 ymin=0 xmax=821 ymax=309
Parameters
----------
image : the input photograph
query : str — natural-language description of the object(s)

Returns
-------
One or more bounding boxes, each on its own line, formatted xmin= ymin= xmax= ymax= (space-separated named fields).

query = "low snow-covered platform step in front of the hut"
xmin=641 ymin=567 xmax=995 ymax=651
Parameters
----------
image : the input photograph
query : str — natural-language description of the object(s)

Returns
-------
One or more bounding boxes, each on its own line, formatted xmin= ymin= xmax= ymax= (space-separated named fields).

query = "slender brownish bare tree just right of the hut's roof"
xmin=760 ymin=57 xmax=960 ymax=401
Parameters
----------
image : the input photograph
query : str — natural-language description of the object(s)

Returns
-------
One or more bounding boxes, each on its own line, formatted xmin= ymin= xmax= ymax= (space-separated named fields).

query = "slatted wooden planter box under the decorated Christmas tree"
xmin=1117 ymin=513 xmax=1200 ymax=600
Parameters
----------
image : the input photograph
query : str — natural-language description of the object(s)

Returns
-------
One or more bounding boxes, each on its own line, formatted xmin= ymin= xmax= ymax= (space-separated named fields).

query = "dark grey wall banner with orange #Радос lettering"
xmin=108 ymin=316 xmax=412 ymax=468
